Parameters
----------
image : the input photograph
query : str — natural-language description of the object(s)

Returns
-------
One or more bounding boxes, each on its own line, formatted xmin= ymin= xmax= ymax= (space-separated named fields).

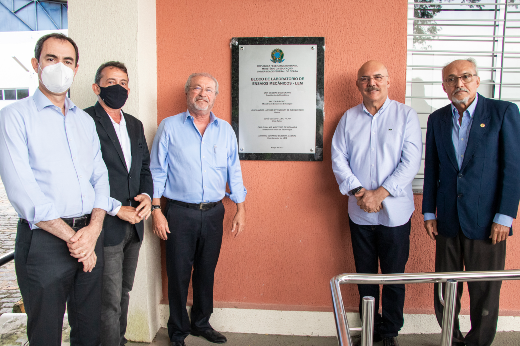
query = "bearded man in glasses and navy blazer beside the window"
xmin=422 ymin=58 xmax=520 ymax=346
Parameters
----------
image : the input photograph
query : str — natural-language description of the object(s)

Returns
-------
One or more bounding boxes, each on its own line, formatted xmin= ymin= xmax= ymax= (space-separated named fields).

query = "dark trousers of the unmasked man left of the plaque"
xmin=166 ymin=202 xmax=225 ymax=341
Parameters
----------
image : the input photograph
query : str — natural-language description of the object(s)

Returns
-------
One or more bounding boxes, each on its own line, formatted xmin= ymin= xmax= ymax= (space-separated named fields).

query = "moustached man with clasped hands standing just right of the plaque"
xmin=332 ymin=61 xmax=422 ymax=346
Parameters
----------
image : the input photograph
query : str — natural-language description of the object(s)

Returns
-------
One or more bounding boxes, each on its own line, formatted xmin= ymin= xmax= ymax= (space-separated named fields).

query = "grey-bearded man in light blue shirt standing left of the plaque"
xmin=150 ymin=73 xmax=246 ymax=346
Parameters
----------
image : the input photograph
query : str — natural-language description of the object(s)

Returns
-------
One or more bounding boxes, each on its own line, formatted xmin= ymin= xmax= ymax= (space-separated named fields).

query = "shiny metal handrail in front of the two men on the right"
xmin=330 ymin=269 xmax=520 ymax=346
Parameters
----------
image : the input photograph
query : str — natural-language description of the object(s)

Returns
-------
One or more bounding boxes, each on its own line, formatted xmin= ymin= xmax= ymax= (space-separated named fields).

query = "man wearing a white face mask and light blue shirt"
xmin=0 ymin=33 xmax=116 ymax=346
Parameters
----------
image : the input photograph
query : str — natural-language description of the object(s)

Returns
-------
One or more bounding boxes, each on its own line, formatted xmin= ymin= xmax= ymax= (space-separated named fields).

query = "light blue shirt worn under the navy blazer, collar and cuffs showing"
xmin=424 ymin=94 xmax=513 ymax=227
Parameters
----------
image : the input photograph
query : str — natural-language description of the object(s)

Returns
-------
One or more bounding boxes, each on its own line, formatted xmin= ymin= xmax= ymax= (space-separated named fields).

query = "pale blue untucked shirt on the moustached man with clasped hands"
xmin=332 ymin=98 xmax=422 ymax=227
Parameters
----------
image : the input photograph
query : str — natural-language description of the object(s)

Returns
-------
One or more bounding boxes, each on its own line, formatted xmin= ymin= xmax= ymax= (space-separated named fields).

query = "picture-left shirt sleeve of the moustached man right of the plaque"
xmin=331 ymin=115 xmax=361 ymax=195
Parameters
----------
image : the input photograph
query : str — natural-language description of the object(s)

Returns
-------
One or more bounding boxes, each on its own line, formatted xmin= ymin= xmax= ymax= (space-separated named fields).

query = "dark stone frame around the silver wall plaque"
xmin=230 ymin=37 xmax=325 ymax=161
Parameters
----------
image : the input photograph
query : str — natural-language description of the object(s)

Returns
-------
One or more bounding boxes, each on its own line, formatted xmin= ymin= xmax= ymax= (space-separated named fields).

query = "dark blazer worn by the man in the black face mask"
xmin=85 ymin=102 xmax=153 ymax=246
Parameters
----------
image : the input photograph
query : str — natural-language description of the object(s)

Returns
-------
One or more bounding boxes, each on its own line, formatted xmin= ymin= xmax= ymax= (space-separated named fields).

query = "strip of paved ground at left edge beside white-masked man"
xmin=0 ymin=180 xmax=22 ymax=315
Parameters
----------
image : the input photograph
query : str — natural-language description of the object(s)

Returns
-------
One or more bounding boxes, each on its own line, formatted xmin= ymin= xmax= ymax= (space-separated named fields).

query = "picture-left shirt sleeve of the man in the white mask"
xmin=0 ymin=108 xmax=60 ymax=224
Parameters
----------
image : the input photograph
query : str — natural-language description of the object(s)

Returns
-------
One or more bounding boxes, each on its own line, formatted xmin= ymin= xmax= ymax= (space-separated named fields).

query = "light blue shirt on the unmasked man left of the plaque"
xmin=150 ymin=111 xmax=247 ymax=203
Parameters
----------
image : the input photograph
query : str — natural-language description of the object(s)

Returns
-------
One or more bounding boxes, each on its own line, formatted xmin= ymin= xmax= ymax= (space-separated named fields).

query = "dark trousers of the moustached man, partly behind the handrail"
xmin=349 ymin=218 xmax=411 ymax=337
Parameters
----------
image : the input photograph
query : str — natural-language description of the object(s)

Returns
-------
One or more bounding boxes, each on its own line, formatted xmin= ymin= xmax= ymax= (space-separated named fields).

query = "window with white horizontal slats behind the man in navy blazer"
xmin=406 ymin=0 xmax=520 ymax=192
